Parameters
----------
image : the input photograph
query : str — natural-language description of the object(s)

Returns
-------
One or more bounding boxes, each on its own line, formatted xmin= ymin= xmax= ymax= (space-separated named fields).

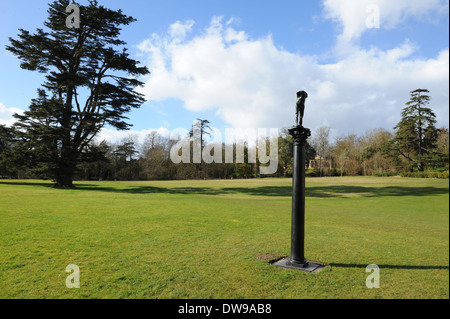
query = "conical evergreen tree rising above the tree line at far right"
xmin=394 ymin=89 xmax=438 ymax=172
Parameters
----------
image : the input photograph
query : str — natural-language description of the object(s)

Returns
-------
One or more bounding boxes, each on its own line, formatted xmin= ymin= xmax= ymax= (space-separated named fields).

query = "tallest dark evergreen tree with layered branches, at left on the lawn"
xmin=6 ymin=0 xmax=149 ymax=188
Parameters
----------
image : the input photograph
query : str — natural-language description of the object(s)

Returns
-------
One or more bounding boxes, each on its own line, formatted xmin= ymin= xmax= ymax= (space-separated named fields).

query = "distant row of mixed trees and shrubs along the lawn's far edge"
xmin=0 ymin=94 xmax=449 ymax=180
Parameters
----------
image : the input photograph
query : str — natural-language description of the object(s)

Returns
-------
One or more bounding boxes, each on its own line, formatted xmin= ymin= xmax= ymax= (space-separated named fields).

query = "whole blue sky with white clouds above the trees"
xmin=0 ymin=0 xmax=449 ymax=139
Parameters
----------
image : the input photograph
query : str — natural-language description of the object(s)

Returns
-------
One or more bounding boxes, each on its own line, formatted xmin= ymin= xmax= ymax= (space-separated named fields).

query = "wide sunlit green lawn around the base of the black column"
xmin=0 ymin=177 xmax=449 ymax=299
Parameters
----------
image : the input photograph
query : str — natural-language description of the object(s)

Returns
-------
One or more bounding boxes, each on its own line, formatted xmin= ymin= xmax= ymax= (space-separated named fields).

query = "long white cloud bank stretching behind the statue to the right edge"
xmin=135 ymin=15 xmax=449 ymax=133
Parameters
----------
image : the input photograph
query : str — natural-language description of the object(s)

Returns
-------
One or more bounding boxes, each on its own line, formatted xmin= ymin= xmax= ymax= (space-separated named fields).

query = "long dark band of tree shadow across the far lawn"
xmin=0 ymin=181 xmax=449 ymax=198
